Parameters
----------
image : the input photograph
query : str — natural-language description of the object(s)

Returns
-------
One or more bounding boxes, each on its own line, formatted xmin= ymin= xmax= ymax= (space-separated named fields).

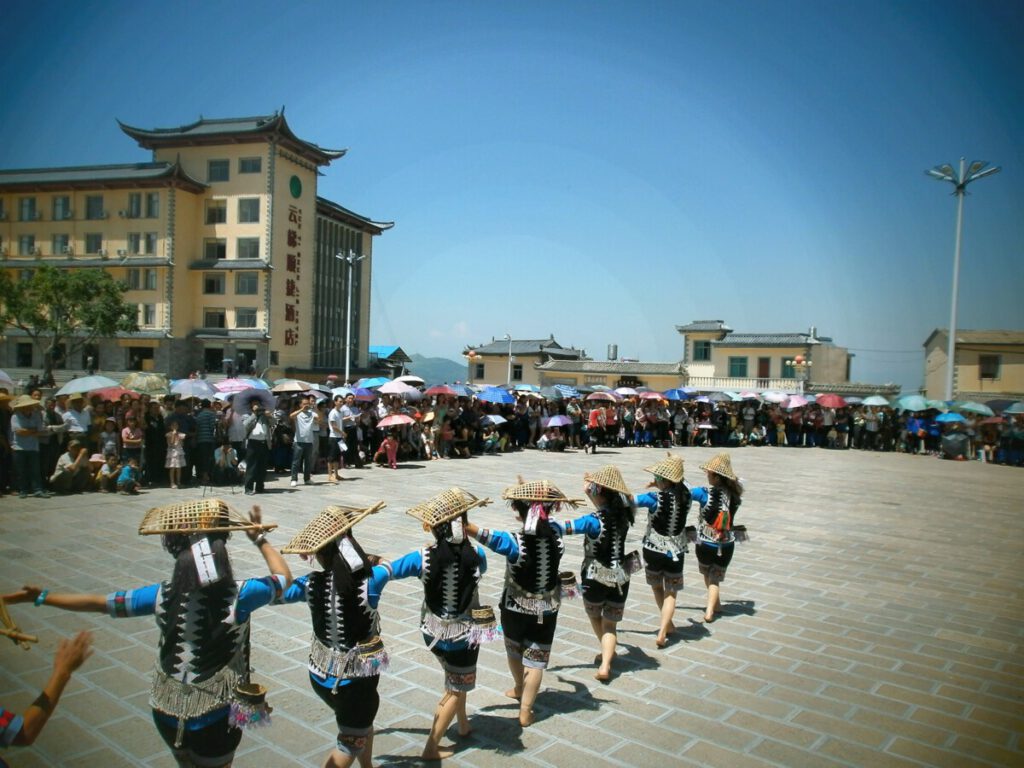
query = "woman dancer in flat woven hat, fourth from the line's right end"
xmin=466 ymin=478 xmax=577 ymax=728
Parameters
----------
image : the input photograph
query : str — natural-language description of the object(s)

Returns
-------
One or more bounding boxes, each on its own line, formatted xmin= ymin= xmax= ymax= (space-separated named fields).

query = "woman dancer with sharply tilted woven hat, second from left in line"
xmin=281 ymin=502 xmax=389 ymax=768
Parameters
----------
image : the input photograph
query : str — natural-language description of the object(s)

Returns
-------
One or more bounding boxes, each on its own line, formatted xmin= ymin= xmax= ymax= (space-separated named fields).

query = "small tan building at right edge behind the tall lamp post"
xmin=925 ymin=328 xmax=1024 ymax=402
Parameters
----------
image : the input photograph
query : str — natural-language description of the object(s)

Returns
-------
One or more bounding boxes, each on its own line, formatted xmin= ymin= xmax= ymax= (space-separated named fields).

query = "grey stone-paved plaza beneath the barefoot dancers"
xmin=0 ymin=447 xmax=1024 ymax=768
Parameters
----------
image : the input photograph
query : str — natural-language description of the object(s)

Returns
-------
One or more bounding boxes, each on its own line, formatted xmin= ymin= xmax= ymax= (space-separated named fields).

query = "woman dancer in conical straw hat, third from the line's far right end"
xmin=561 ymin=464 xmax=639 ymax=683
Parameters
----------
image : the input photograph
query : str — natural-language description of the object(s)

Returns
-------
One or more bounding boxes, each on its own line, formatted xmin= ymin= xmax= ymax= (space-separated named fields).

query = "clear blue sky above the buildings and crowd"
xmin=0 ymin=0 xmax=1024 ymax=388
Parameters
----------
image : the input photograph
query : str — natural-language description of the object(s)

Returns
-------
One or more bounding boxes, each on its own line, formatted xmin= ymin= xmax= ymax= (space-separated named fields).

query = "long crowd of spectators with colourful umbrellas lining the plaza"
xmin=0 ymin=389 xmax=1024 ymax=496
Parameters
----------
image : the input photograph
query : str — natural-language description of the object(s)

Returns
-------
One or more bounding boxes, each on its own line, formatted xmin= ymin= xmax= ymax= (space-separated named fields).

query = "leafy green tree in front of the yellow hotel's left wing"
xmin=0 ymin=265 xmax=138 ymax=380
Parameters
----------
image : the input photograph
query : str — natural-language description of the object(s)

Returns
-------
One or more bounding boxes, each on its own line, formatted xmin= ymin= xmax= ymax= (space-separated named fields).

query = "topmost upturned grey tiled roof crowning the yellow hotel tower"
xmin=118 ymin=110 xmax=348 ymax=165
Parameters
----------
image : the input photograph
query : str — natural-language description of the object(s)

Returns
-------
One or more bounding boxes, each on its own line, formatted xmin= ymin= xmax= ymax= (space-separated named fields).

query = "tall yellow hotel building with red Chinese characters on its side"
xmin=0 ymin=112 xmax=392 ymax=376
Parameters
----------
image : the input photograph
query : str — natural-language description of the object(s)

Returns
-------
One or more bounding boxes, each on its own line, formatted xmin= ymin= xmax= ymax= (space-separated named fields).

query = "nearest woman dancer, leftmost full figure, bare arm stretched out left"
xmin=5 ymin=499 xmax=292 ymax=768
